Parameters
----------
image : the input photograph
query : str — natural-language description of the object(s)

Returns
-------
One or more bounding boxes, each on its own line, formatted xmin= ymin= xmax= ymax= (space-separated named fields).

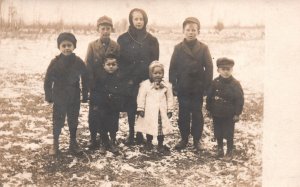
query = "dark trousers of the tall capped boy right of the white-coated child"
xmin=178 ymin=95 xmax=204 ymax=141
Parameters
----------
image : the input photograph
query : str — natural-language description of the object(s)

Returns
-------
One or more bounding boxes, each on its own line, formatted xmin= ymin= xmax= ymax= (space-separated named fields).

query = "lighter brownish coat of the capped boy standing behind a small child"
xmin=85 ymin=39 xmax=120 ymax=93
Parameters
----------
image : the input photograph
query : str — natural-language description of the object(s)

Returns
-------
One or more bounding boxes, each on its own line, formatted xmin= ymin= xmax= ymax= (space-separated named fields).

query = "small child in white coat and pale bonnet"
xmin=136 ymin=61 xmax=173 ymax=152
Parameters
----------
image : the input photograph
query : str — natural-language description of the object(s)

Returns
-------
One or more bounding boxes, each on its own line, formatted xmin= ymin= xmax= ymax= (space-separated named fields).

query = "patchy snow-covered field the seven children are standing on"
xmin=0 ymin=30 xmax=265 ymax=186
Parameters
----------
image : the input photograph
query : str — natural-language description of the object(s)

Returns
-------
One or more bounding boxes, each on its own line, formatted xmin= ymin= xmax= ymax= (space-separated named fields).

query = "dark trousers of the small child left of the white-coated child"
xmin=97 ymin=106 xmax=119 ymax=144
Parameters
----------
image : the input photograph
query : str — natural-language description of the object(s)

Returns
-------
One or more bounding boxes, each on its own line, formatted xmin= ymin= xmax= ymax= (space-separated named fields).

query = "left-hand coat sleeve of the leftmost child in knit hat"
xmin=44 ymin=60 xmax=55 ymax=102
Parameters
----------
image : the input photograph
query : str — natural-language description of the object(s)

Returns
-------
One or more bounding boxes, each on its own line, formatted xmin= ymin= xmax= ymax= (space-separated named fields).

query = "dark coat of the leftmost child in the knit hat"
xmin=44 ymin=53 xmax=88 ymax=105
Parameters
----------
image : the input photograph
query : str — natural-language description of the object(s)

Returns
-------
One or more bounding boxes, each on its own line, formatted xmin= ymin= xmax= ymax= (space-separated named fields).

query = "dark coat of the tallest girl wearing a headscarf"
xmin=117 ymin=29 xmax=159 ymax=97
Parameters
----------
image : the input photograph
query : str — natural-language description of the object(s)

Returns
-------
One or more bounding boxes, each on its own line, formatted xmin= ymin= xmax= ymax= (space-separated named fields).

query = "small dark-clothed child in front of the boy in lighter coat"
xmin=91 ymin=55 xmax=124 ymax=154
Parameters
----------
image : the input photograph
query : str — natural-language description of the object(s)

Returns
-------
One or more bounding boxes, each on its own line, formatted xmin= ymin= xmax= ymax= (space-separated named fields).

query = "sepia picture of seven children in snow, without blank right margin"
xmin=0 ymin=0 xmax=300 ymax=187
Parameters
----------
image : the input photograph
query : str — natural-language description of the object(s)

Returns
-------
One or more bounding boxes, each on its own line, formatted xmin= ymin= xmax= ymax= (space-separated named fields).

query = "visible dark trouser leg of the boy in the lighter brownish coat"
xmin=88 ymin=101 xmax=99 ymax=141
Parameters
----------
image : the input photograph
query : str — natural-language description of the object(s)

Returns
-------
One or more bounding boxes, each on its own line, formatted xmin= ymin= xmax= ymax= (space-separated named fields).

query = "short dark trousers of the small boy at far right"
xmin=213 ymin=117 xmax=235 ymax=150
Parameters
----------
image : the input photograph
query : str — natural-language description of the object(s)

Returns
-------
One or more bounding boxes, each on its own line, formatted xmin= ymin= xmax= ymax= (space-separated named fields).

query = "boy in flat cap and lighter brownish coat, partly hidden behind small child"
xmin=85 ymin=16 xmax=120 ymax=150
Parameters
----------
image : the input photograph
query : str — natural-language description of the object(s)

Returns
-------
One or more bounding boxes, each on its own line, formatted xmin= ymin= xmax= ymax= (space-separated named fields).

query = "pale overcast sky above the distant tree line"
xmin=1 ymin=0 xmax=267 ymax=26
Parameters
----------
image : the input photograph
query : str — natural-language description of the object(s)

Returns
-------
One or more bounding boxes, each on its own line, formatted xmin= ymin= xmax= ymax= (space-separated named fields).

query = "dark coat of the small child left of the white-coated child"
xmin=91 ymin=70 xmax=125 ymax=111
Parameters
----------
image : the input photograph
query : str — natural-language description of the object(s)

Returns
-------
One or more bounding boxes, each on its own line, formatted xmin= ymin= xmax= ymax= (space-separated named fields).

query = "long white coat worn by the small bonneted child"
xmin=136 ymin=80 xmax=173 ymax=136
